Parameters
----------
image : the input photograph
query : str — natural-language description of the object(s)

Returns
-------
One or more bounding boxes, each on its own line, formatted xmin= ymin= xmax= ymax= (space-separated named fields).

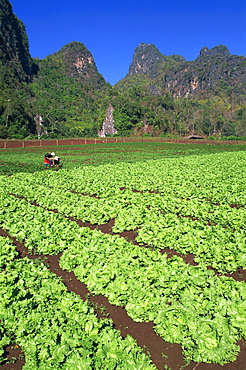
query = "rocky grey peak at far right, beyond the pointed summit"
xmin=163 ymin=45 xmax=246 ymax=98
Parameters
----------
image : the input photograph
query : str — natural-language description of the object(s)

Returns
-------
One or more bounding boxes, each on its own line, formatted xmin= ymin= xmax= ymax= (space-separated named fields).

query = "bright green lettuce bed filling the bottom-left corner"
xmin=0 ymin=237 xmax=155 ymax=370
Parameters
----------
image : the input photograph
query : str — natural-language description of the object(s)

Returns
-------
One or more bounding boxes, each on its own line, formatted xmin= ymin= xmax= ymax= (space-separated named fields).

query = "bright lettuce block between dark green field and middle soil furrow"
xmin=3 ymin=152 xmax=246 ymax=273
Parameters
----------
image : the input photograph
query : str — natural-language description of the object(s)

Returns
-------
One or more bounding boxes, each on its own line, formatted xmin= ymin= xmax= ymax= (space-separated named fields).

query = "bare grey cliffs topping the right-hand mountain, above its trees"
xmin=124 ymin=44 xmax=246 ymax=98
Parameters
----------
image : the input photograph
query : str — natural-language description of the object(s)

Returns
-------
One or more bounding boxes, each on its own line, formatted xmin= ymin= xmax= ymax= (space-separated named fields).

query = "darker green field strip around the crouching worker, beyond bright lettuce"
xmin=0 ymin=142 xmax=246 ymax=175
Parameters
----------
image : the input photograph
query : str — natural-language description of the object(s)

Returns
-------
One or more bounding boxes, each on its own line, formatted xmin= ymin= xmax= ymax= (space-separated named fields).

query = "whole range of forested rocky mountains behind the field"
xmin=0 ymin=0 xmax=246 ymax=139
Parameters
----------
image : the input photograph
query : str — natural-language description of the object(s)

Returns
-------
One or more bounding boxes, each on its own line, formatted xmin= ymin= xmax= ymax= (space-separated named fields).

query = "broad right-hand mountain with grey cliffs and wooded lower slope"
xmin=116 ymin=44 xmax=246 ymax=136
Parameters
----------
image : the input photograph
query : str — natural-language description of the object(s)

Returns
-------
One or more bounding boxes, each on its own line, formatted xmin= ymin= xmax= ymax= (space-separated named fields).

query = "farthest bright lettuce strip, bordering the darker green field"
xmin=16 ymin=152 xmax=246 ymax=206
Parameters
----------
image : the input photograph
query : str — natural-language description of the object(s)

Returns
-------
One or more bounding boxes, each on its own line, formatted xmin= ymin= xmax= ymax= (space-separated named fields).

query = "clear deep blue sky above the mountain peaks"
xmin=10 ymin=0 xmax=246 ymax=85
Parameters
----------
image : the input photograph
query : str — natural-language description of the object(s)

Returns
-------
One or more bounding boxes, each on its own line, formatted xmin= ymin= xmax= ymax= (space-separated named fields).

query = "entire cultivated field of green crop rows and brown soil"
xmin=0 ymin=143 xmax=246 ymax=370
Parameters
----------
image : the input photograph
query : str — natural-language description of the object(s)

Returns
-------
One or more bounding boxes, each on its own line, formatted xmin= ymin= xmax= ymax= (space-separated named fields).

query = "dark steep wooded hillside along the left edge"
xmin=0 ymin=0 xmax=38 ymax=138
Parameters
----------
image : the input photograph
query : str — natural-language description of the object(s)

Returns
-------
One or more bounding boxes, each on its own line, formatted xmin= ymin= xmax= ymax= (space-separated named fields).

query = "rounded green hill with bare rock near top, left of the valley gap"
xmin=32 ymin=42 xmax=111 ymax=137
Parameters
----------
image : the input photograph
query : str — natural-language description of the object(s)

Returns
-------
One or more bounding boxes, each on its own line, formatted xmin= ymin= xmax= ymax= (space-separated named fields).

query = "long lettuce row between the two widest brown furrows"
xmin=0 ymin=191 xmax=246 ymax=364
